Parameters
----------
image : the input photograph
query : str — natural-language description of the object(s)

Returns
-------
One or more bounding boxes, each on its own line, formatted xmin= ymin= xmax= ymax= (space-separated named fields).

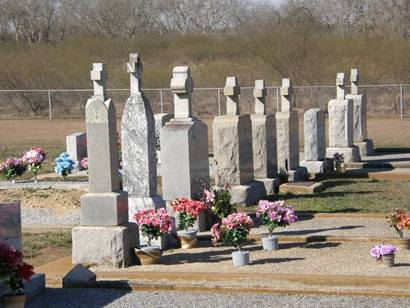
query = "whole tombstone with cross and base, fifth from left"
xmin=251 ymin=80 xmax=278 ymax=195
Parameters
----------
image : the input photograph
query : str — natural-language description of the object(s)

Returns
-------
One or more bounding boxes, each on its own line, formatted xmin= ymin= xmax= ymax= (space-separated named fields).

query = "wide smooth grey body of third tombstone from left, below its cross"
xmin=161 ymin=118 xmax=209 ymax=200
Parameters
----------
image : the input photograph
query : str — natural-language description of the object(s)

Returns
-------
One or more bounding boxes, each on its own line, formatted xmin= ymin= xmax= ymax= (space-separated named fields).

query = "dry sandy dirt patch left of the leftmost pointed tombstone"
xmin=0 ymin=188 xmax=85 ymax=213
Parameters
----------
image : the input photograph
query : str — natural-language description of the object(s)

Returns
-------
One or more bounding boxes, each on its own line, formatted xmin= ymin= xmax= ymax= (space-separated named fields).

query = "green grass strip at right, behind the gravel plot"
xmin=238 ymin=179 xmax=410 ymax=213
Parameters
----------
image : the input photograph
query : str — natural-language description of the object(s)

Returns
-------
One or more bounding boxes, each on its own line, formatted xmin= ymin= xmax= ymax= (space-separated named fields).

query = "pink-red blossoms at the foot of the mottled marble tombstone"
xmin=134 ymin=208 xmax=173 ymax=233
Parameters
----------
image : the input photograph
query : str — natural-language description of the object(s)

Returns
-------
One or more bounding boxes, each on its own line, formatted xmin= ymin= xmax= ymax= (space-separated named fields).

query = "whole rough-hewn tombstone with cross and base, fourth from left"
xmin=213 ymin=77 xmax=266 ymax=204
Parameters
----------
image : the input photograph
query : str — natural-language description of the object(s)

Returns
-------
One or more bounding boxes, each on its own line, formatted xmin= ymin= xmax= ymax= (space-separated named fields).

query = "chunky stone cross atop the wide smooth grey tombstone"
xmin=171 ymin=66 xmax=194 ymax=118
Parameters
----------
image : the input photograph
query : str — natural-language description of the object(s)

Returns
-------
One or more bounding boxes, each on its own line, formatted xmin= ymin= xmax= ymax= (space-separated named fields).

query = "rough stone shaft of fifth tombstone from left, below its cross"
xmin=251 ymin=114 xmax=278 ymax=179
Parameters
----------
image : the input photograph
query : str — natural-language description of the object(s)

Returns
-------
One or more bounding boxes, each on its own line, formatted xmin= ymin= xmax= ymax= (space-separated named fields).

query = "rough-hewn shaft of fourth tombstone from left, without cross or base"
xmin=213 ymin=115 xmax=254 ymax=185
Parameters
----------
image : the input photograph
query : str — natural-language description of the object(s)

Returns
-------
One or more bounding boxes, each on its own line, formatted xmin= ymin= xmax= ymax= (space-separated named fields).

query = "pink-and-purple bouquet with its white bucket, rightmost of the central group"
xmin=256 ymin=200 xmax=298 ymax=251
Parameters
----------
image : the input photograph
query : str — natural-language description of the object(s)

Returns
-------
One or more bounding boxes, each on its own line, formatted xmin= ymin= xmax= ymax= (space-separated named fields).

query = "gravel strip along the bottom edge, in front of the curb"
xmin=26 ymin=289 xmax=410 ymax=308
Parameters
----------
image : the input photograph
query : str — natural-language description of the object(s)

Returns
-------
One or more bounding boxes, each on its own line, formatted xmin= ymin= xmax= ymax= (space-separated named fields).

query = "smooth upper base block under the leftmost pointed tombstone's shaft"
xmin=81 ymin=191 xmax=128 ymax=226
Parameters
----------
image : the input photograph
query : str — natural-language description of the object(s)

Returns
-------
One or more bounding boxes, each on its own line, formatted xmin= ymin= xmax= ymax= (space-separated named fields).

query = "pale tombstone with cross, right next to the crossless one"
xmin=326 ymin=73 xmax=360 ymax=162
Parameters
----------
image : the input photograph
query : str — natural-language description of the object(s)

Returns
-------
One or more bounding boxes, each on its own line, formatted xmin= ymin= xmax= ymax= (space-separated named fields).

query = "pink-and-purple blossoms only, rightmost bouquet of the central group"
xmin=256 ymin=200 xmax=298 ymax=226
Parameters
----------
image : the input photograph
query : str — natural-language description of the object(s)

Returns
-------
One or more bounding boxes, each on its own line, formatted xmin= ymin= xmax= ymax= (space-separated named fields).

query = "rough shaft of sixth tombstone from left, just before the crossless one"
xmin=276 ymin=110 xmax=299 ymax=173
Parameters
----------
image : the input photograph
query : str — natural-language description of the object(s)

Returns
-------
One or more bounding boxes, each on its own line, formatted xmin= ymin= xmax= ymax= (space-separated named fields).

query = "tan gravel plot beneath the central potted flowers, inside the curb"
xmin=91 ymin=242 xmax=410 ymax=276
